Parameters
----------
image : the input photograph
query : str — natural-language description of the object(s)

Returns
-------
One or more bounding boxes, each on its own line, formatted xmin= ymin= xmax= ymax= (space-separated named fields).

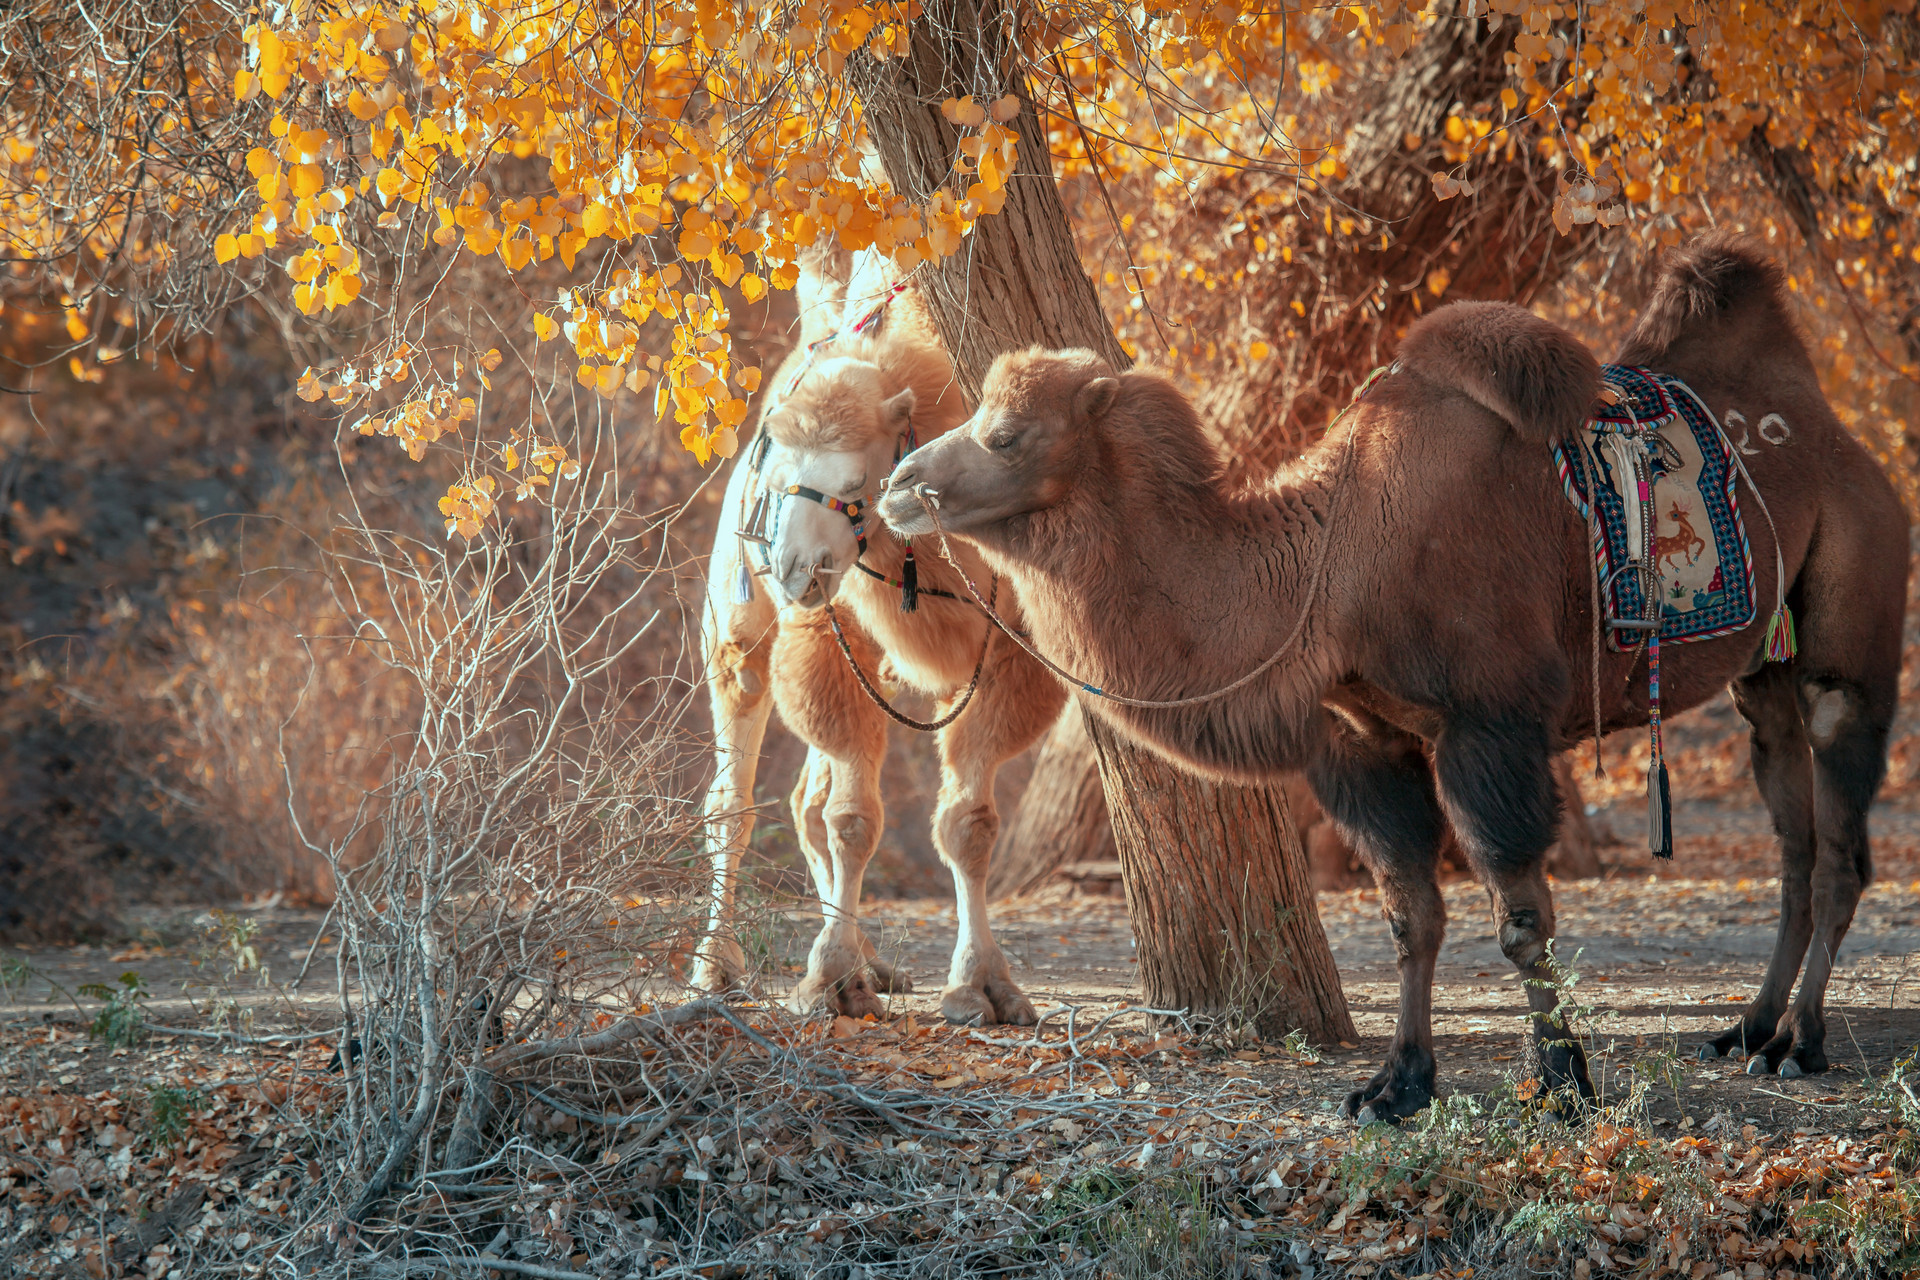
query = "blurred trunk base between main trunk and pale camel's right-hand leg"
xmin=987 ymin=706 xmax=1119 ymax=898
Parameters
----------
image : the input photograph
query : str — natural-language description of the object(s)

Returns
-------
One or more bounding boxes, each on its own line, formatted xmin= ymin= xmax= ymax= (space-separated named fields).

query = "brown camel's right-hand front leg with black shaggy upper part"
xmin=1434 ymin=710 xmax=1594 ymax=1100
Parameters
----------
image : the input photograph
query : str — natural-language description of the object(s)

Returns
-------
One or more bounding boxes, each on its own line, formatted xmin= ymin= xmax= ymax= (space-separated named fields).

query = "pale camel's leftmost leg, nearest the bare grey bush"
xmin=689 ymin=621 xmax=774 ymax=990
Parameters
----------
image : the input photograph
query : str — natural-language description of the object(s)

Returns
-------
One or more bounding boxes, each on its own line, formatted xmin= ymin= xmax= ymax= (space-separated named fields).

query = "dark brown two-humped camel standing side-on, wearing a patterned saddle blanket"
xmin=881 ymin=236 xmax=1907 ymax=1121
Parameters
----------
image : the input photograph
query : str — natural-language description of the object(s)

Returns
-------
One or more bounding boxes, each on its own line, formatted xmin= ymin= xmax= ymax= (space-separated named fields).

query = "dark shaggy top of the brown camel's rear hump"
xmin=1620 ymin=230 xmax=1797 ymax=367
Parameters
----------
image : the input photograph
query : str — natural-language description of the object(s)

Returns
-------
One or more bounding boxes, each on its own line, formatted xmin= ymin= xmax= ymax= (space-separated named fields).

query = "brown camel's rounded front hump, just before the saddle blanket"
xmin=1400 ymin=301 xmax=1599 ymax=439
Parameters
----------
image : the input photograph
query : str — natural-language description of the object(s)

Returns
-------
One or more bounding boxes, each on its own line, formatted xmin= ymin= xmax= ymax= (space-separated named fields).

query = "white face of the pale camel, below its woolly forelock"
xmin=760 ymin=443 xmax=893 ymax=608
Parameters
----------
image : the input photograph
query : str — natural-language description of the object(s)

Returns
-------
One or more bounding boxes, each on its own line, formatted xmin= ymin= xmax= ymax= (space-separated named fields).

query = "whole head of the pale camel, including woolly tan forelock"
xmin=758 ymin=357 xmax=914 ymax=608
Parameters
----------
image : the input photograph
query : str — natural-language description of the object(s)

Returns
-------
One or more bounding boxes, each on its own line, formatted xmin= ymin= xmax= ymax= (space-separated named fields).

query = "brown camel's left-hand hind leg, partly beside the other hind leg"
xmin=1699 ymin=662 xmax=1814 ymax=1059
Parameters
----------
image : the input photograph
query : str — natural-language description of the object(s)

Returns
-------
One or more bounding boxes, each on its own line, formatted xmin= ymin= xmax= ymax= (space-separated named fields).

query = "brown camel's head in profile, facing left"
xmin=879 ymin=347 xmax=1119 ymax=535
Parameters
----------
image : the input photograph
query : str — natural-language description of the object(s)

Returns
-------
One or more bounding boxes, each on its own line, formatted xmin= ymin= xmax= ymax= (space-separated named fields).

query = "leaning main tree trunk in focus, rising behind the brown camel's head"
xmin=849 ymin=0 xmax=1352 ymax=1040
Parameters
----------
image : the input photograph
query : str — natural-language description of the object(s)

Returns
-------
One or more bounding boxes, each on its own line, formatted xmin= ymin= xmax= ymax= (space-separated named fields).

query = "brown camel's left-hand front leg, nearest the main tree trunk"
xmin=1308 ymin=722 xmax=1446 ymax=1125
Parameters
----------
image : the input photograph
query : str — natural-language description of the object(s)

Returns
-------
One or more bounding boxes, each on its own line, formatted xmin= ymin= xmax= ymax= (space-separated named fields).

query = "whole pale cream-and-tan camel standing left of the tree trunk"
xmin=693 ymin=259 xmax=1066 ymax=1023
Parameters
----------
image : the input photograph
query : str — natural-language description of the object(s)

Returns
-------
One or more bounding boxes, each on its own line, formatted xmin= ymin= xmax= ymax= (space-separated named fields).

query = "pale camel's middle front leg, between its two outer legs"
xmin=787 ymin=752 xmax=906 ymax=1017
